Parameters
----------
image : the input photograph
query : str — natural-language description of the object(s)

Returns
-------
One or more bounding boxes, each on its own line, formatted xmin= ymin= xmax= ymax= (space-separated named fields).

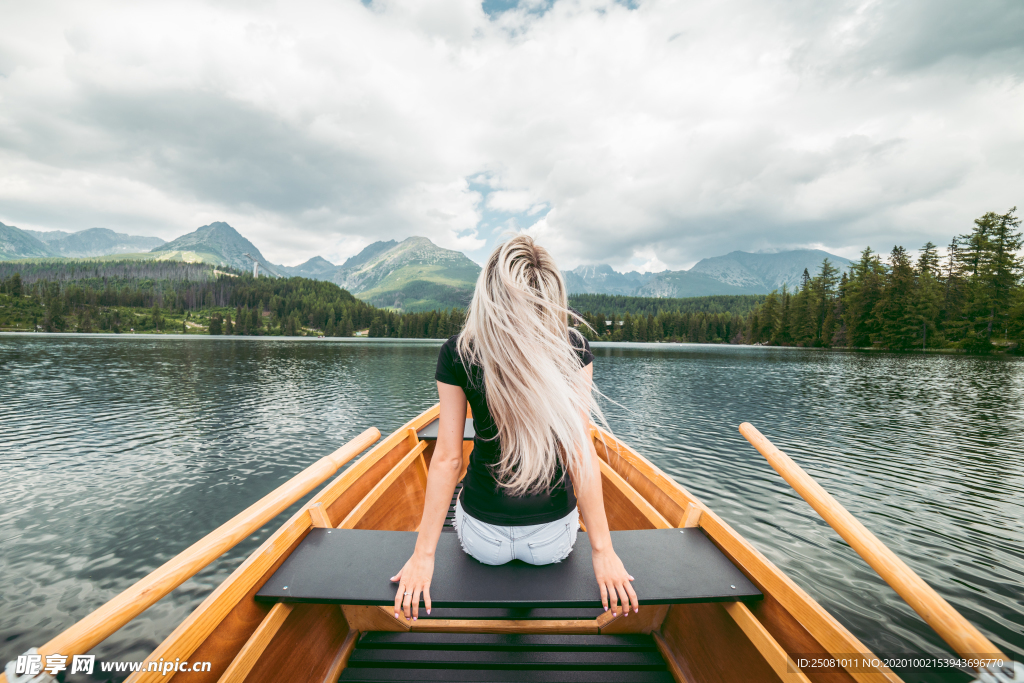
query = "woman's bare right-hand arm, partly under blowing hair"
xmin=570 ymin=364 xmax=640 ymax=616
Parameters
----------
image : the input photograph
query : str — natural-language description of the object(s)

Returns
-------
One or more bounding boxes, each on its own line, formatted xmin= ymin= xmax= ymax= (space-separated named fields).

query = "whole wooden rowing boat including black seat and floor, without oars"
xmin=117 ymin=405 xmax=900 ymax=683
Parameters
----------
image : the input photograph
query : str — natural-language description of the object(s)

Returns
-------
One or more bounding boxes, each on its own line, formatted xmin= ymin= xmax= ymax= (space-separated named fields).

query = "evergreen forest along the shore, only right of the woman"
xmin=575 ymin=208 xmax=1024 ymax=353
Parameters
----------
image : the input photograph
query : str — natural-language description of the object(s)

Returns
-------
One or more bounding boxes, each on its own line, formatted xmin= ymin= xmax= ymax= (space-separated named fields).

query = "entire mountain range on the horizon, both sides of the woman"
xmin=0 ymin=222 xmax=850 ymax=311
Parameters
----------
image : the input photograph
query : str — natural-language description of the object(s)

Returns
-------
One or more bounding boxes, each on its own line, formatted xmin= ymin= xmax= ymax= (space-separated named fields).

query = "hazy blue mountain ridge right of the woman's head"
xmin=562 ymin=249 xmax=850 ymax=298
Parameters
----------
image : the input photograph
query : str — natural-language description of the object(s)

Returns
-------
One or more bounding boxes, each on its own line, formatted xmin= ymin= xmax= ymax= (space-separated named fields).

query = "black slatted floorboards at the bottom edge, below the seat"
xmin=340 ymin=632 xmax=673 ymax=683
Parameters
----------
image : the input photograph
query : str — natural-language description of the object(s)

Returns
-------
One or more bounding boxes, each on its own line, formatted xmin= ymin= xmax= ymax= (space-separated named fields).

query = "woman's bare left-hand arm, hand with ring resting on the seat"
xmin=391 ymin=382 xmax=466 ymax=620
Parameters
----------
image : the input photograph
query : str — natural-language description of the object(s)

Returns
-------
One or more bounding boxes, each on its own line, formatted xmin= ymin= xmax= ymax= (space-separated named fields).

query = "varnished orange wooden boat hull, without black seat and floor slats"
xmin=123 ymin=405 xmax=900 ymax=683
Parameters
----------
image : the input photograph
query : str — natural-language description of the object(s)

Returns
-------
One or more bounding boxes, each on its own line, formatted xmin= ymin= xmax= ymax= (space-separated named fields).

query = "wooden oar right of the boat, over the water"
xmin=739 ymin=422 xmax=1010 ymax=661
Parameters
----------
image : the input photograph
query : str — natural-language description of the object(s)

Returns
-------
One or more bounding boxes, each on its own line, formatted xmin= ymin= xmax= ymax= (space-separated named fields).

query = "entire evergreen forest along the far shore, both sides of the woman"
xmin=0 ymin=209 xmax=1024 ymax=353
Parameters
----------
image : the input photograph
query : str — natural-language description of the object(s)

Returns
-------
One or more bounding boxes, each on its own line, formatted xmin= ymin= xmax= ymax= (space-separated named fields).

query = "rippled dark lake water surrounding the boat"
xmin=0 ymin=335 xmax=1024 ymax=681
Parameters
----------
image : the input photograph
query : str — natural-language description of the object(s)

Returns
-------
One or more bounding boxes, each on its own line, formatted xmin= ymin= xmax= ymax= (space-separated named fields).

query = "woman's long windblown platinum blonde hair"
xmin=458 ymin=234 xmax=604 ymax=496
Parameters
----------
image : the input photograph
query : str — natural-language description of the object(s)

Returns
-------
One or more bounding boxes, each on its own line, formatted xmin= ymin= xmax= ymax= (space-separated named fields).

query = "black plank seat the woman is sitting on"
xmin=256 ymin=528 xmax=763 ymax=608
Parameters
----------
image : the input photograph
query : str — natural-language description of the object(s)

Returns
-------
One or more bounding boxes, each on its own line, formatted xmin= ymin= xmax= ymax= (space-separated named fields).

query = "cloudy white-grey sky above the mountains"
xmin=0 ymin=0 xmax=1024 ymax=270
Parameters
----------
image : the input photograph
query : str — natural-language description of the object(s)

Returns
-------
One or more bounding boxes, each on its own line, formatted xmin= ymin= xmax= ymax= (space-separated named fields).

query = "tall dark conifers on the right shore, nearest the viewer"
xmin=744 ymin=208 xmax=1024 ymax=352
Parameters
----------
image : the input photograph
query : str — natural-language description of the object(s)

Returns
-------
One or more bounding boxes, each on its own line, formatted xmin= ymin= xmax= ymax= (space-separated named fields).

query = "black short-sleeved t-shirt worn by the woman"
xmin=434 ymin=334 xmax=594 ymax=526
